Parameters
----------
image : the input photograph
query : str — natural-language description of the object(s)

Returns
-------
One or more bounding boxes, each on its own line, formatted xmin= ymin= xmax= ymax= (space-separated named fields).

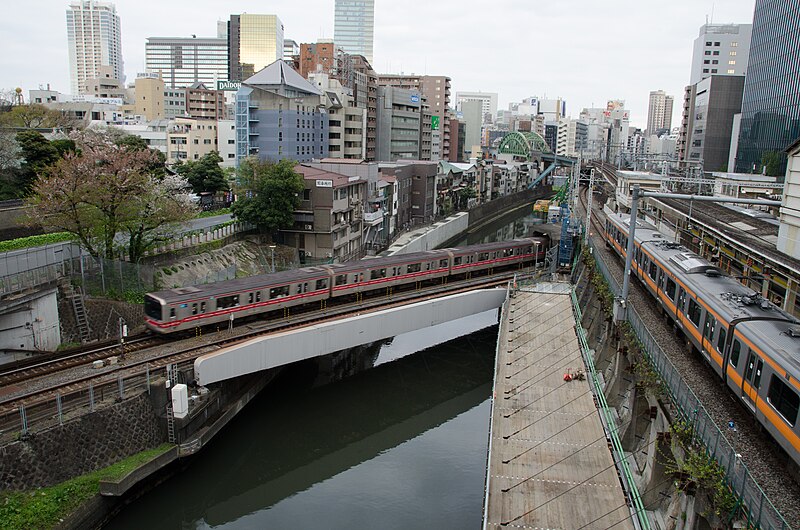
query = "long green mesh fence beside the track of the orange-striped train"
xmin=589 ymin=242 xmax=791 ymax=530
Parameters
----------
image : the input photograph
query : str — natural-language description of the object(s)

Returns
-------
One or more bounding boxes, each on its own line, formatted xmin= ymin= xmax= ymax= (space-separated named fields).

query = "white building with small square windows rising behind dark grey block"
xmin=689 ymin=24 xmax=753 ymax=85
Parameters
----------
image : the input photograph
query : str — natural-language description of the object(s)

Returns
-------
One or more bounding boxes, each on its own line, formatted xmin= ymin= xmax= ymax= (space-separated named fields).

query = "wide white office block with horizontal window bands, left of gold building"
xmin=144 ymin=37 xmax=228 ymax=88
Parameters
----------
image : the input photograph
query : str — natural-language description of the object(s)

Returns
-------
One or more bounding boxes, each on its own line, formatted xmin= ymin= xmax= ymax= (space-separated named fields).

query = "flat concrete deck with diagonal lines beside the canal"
xmin=484 ymin=283 xmax=634 ymax=530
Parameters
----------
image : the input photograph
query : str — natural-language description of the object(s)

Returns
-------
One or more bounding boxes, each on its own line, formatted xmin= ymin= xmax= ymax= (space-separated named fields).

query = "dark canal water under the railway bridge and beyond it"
xmin=107 ymin=207 xmax=548 ymax=530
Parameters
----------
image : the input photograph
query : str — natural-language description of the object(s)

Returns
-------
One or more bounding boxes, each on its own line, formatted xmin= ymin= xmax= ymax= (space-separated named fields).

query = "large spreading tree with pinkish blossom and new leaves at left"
xmin=28 ymin=131 xmax=196 ymax=261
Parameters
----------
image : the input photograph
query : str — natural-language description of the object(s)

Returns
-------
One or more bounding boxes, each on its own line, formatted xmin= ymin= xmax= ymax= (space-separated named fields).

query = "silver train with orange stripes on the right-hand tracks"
xmin=603 ymin=214 xmax=800 ymax=465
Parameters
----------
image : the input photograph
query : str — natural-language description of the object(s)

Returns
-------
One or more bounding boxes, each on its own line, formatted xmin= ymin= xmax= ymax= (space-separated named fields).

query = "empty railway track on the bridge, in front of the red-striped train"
xmin=0 ymin=271 xmax=516 ymax=433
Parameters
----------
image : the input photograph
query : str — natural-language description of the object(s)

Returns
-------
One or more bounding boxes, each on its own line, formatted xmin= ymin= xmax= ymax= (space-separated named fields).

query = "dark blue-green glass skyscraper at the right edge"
xmin=730 ymin=0 xmax=800 ymax=173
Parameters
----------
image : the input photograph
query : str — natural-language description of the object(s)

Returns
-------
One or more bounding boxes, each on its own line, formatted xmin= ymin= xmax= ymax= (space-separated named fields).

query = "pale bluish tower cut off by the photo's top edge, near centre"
xmin=333 ymin=0 xmax=375 ymax=63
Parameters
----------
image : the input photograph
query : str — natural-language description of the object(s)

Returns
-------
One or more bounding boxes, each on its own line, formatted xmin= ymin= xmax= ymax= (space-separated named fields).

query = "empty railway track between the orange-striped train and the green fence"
xmin=579 ymin=184 xmax=800 ymax=522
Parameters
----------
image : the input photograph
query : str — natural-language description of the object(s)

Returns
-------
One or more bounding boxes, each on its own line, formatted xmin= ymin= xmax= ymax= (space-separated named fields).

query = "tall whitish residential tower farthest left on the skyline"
xmin=67 ymin=0 xmax=125 ymax=94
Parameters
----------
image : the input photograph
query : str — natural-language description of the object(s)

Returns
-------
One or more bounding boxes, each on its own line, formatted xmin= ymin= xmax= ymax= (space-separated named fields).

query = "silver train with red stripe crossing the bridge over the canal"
xmin=144 ymin=236 xmax=550 ymax=334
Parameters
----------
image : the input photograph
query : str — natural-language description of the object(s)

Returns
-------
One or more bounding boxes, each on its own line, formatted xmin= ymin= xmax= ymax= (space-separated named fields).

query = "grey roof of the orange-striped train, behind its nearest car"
xmin=609 ymin=210 xmax=795 ymax=322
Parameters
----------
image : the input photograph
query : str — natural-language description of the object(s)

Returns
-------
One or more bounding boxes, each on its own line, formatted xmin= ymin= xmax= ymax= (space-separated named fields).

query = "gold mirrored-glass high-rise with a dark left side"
xmin=228 ymin=13 xmax=283 ymax=81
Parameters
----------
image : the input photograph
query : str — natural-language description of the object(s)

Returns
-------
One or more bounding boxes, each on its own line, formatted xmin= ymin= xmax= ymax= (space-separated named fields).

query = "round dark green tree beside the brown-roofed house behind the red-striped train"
xmin=231 ymin=157 xmax=305 ymax=232
